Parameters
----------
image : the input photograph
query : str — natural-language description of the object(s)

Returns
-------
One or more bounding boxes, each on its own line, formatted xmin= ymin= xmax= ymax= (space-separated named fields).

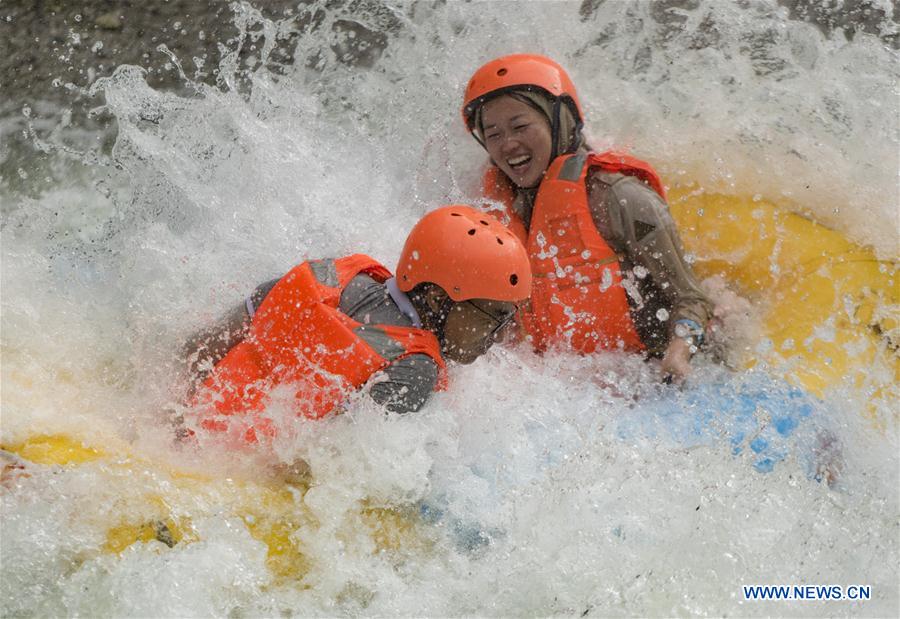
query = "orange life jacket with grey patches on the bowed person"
xmin=193 ymin=254 xmax=446 ymax=443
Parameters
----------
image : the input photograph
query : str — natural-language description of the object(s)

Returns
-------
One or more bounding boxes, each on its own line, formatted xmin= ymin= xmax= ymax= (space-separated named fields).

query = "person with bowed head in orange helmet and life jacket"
xmin=180 ymin=205 xmax=531 ymax=445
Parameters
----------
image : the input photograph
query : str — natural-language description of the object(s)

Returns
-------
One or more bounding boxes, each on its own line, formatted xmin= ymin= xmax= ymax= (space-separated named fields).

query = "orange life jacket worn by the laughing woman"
xmin=484 ymin=151 xmax=665 ymax=354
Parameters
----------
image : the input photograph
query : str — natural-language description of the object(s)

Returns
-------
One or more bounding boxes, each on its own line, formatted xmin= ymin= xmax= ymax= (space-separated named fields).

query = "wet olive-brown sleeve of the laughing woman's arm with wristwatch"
xmin=590 ymin=174 xmax=712 ymax=330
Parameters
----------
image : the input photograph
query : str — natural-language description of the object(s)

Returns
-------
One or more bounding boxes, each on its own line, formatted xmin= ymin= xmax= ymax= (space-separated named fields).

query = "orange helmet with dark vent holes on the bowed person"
xmin=397 ymin=204 xmax=531 ymax=302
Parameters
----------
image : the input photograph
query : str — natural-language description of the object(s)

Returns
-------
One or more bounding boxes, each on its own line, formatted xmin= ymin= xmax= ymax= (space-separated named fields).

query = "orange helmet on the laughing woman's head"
xmin=462 ymin=54 xmax=584 ymax=131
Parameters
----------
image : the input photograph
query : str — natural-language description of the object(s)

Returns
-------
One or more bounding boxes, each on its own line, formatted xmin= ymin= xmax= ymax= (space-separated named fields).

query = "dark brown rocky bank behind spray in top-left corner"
xmin=0 ymin=0 xmax=298 ymax=108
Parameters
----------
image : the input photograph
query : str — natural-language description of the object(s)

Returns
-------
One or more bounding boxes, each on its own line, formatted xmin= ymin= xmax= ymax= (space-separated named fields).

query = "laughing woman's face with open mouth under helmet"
xmin=481 ymin=95 xmax=553 ymax=187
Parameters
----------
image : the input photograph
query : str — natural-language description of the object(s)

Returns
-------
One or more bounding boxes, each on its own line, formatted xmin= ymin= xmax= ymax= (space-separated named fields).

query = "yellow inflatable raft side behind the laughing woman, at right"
xmin=669 ymin=185 xmax=900 ymax=421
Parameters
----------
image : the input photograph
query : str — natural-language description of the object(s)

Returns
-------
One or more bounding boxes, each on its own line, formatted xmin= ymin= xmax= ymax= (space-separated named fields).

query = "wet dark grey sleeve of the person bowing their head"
xmin=369 ymin=354 xmax=438 ymax=413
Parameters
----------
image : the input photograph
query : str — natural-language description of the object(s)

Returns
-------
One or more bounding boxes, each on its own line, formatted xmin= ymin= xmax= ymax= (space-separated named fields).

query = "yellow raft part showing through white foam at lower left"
xmin=0 ymin=434 xmax=432 ymax=585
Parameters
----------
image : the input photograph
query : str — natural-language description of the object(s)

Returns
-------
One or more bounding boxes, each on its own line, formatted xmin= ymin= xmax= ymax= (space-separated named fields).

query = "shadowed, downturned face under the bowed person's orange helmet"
xmin=441 ymin=299 xmax=516 ymax=364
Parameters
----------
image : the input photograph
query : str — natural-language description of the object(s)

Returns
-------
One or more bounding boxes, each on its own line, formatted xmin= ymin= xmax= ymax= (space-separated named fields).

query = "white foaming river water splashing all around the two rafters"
xmin=0 ymin=0 xmax=900 ymax=617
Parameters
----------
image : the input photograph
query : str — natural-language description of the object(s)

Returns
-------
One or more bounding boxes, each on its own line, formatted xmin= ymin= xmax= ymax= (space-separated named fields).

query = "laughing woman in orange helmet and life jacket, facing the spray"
xmin=462 ymin=54 xmax=712 ymax=380
